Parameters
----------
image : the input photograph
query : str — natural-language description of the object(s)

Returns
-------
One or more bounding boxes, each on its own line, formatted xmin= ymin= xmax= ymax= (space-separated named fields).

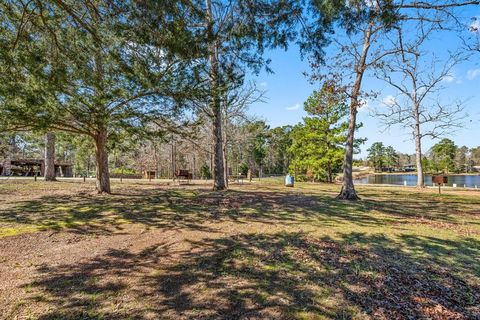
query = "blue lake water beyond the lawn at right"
xmin=355 ymin=174 xmax=480 ymax=188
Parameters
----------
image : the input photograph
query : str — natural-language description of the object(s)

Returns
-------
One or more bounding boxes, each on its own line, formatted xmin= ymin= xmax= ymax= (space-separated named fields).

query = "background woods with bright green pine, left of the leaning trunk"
xmin=0 ymin=82 xmax=363 ymax=184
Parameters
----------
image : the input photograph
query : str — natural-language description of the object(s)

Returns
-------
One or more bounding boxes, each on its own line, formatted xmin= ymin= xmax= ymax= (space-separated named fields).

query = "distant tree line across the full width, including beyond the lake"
xmin=4 ymin=117 xmax=480 ymax=182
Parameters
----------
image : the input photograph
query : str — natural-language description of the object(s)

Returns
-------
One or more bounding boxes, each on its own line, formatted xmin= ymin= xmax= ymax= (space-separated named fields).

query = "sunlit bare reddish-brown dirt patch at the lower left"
xmin=0 ymin=225 xmax=202 ymax=319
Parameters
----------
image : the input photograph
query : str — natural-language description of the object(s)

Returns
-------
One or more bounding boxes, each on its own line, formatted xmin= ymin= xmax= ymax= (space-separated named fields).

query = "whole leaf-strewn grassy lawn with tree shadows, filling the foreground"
xmin=0 ymin=180 xmax=480 ymax=319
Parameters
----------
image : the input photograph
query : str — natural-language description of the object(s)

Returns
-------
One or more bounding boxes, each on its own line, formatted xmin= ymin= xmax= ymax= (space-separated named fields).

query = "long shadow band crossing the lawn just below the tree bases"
xmin=0 ymin=189 xmax=386 ymax=234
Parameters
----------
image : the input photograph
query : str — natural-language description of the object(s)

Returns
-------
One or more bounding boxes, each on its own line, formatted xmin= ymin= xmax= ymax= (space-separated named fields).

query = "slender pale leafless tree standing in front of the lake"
xmin=376 ymin=21 xmax=466 ymax=188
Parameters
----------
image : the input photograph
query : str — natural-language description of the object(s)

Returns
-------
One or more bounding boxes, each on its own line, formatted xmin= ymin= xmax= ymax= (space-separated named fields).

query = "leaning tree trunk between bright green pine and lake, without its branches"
xmin=337 ymin=22 xmax=373 ymax=200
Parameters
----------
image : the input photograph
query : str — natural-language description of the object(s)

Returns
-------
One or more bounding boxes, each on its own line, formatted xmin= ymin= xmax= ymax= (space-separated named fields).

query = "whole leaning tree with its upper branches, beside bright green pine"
xmin=312 ymin=0 xmax=480 ymax=200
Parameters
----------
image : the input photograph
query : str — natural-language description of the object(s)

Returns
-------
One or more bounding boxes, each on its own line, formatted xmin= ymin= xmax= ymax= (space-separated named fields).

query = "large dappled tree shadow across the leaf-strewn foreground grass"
xmin=20 ymin=233 xmax=480 ymax=319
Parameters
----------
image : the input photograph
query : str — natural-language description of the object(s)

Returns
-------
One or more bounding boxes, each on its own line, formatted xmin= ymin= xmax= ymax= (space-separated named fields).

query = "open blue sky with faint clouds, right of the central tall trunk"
xmin=250 ymin=9 xmax=480 ymax=157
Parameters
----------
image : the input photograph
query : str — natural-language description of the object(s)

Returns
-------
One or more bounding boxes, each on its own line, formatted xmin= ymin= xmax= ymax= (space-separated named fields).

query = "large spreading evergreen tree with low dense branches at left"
xmin=0 ymin=0 xmax=199 ymax=193
